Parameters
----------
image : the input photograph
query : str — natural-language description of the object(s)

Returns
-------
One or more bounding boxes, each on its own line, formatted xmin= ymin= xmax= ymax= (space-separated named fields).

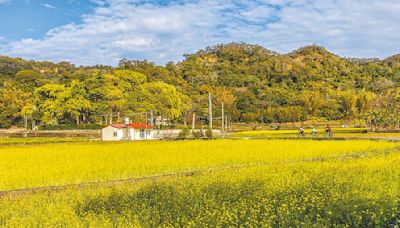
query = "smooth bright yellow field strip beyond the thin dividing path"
xmin=0 ymin=140 xmax=398 ymax=191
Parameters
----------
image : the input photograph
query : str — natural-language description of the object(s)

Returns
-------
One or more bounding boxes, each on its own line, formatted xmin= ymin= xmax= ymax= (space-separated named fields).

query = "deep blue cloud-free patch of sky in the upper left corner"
xmin=0 ymin=0 xmax=96 ymax=40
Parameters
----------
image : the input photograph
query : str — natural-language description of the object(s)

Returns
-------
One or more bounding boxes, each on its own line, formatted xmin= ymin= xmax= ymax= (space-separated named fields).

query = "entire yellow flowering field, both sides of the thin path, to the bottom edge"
xmin=0 ymin=140 xmax=400 ymax=227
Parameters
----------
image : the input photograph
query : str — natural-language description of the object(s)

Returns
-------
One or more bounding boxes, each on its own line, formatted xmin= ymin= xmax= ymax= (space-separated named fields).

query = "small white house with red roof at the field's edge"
xmin=101 ymin=123 xmax=154 ymax=141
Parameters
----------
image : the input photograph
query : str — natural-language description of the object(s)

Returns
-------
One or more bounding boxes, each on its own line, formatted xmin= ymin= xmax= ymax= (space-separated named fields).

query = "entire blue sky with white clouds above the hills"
xmin=0 ymin=0 xmax=400 ymax=66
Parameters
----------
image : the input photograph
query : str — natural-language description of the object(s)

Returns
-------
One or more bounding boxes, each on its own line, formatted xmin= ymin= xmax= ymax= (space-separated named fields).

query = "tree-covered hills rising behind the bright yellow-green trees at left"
xmin=0 ymin=43 xmax=400 ymax=128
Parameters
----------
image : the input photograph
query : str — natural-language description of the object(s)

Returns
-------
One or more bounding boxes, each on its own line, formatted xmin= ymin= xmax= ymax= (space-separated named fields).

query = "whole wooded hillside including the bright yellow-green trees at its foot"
xmin=0 ymin=43 xmax=400 ymax=128
